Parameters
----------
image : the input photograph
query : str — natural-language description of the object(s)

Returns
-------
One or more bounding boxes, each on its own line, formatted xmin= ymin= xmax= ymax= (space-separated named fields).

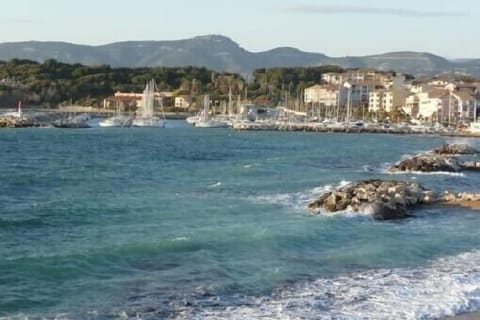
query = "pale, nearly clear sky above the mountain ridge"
xmin=0 ymin=0 xmax=480 ymax=59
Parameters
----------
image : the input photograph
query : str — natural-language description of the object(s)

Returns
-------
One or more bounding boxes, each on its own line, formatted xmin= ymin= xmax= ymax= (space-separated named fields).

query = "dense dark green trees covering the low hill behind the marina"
xmin=0 ymin=59 xmax=342 ymax=107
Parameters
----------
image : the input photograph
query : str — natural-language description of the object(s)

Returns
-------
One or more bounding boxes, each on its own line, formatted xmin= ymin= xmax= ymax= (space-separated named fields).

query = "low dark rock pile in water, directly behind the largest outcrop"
xmin=389 ymin=154 xmax=463 ymax=172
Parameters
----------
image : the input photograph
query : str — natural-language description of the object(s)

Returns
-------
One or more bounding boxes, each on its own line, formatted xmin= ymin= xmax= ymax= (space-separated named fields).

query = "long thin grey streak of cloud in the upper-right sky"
xmin=276 ymin=5 xmax=467 ymax=17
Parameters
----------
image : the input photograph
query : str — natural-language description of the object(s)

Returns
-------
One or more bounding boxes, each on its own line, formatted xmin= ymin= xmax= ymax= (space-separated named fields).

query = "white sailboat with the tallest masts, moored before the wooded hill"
xmin=132 ymin=79 xmax=166 ymax=128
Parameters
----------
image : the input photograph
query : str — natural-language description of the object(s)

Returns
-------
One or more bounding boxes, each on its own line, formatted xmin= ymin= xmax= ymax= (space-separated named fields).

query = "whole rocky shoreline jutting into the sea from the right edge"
xmin=308 ymin=145 xmax=480 ymax=220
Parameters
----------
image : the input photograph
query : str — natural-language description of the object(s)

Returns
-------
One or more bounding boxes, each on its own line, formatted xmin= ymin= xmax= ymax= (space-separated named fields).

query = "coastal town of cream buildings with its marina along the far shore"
xmin=0 ymin=69 xmax=480 ymax=135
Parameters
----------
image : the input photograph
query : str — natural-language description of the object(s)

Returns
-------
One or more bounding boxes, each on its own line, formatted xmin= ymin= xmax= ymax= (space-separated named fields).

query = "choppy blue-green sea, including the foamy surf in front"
xmin=0 ymin=121 xmax=480 ymax=320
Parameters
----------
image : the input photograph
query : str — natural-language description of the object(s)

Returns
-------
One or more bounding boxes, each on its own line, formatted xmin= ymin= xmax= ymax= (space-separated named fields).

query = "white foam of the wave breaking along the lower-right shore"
xmin=175 ymin=251 xmax=480 ymax=320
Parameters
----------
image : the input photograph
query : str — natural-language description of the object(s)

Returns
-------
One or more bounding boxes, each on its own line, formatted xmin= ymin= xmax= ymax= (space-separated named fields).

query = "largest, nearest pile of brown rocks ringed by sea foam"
xmin=308 ymin=180 xmax=439 ymax=220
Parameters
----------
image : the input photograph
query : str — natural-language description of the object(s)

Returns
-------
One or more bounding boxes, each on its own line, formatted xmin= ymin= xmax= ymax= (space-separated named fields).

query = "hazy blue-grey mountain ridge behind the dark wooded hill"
xmin=0 ymin=35 xmax=480 ymax=77
